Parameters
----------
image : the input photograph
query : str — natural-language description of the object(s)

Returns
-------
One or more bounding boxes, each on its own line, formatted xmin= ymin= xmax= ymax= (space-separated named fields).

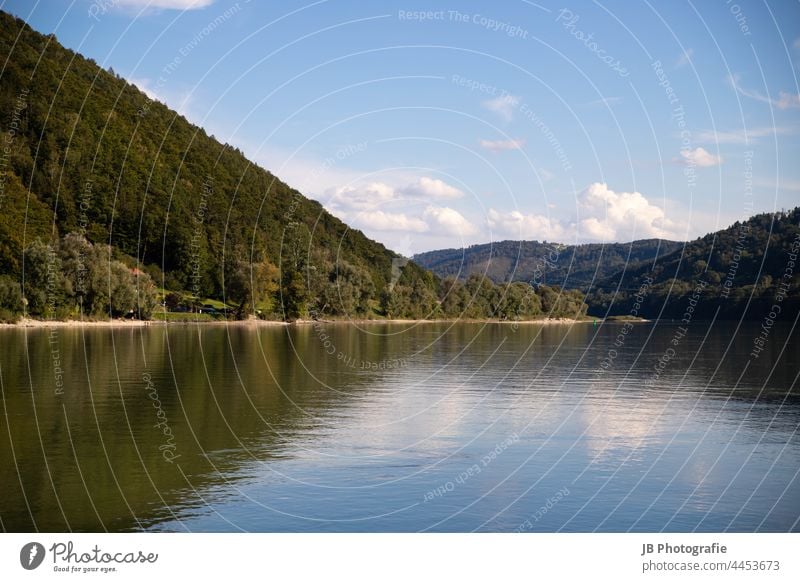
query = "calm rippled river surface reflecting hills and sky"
xmin=0 ymin=323 xmax=800 ymax=531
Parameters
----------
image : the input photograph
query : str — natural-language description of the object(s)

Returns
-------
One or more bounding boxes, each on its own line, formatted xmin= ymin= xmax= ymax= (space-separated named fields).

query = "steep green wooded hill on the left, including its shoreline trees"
xmin=0 ymin=11 xmax=587 ymax=320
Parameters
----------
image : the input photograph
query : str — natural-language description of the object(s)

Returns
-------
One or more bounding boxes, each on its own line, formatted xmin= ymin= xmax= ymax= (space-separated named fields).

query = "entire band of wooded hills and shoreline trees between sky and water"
xmin=9 ymin=12 xmax=800 ymax=320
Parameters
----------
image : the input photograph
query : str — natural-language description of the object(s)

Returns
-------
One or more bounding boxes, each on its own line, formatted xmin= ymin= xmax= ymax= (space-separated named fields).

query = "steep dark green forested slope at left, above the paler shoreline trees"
xmin=0 ymin=13 xmax=427 ymax=320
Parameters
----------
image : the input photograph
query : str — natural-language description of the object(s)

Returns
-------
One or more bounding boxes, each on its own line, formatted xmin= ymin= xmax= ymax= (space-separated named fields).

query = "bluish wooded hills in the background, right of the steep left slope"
xmin=414 ymin=208 xmax=800 ymax=320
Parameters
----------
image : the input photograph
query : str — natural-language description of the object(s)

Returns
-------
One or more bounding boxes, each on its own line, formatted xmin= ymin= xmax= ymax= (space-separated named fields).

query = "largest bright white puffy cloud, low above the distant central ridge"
xmin=486 ymin=182 xmax=686 ymax=243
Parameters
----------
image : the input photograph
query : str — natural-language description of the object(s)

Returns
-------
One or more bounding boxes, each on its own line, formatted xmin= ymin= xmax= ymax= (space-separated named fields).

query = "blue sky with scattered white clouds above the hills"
xmin=2 ymin=0 xmax=800 ymax=255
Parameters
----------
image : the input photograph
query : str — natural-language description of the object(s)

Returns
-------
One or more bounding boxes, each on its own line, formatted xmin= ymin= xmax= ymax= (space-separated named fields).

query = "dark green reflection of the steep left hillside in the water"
xmin=0 ymin=326 xmax=406 ymax=531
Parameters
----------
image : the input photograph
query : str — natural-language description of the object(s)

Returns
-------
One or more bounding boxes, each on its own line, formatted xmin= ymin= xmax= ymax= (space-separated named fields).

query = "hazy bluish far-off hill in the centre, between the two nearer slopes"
xmin=414 ymin=239 xmax=682 ymax=290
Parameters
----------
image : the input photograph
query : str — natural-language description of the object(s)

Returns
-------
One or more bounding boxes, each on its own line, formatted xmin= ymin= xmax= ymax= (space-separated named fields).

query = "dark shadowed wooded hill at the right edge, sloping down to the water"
xmin=587 ymin=208 xmax=800 ymax=321
